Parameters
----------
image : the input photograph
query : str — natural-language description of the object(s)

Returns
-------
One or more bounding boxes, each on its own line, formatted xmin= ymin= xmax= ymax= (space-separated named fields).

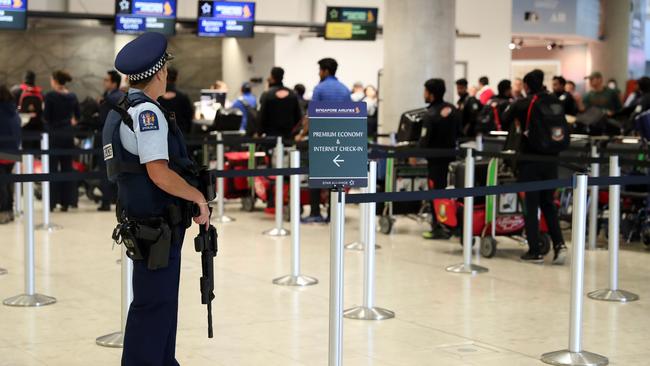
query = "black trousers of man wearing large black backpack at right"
xmin=518 ymin=162 xmax=564 ymax=254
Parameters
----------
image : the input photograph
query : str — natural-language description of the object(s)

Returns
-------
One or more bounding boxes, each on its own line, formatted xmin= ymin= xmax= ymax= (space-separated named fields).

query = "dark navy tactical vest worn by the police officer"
xmin=102 ymin=92 xmax=196 ymax=218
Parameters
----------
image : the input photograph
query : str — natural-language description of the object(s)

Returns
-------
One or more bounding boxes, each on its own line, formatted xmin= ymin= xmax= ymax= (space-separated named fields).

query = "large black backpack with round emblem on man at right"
xmin=526 ymin=94 xmax=570 ymax=154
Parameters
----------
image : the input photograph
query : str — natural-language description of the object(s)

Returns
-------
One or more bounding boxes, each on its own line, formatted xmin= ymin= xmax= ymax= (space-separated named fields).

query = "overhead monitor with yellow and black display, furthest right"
xmin=325 ymin=6 xmax=378 ymax=41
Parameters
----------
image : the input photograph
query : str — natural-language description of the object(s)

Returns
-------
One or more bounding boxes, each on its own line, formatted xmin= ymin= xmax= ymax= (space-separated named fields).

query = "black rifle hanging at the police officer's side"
xmin=194 ymin=168 xmax=218 ymax=338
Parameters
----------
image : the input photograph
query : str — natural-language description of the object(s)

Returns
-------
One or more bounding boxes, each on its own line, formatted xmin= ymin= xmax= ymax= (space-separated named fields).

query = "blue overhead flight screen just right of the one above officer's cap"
xmin=198 ymin=1 xmax=255 ymax=38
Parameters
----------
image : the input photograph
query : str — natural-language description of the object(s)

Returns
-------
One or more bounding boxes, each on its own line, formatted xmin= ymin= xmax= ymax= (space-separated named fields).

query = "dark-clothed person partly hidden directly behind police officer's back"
xmin=97 ymin=70 xmax=124 ymax=211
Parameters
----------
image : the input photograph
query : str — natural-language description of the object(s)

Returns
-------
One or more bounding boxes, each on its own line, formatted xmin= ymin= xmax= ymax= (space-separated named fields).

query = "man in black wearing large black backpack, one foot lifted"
xmin=504 ymin=69 xmax=567 ymax=265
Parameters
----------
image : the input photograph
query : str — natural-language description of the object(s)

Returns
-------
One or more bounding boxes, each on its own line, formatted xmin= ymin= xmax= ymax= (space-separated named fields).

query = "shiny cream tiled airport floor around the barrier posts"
xmin=0 ymin=199 xmax=650 ymax=366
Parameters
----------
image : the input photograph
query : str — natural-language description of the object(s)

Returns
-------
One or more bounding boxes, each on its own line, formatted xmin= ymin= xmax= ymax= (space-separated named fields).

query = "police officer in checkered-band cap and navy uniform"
xmin=103 ymin=33 xmax=210 ymax=365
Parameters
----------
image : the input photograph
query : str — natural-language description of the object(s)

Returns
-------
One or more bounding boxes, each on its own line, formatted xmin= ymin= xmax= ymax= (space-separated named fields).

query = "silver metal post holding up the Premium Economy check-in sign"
xmin=328 ymin=188 xmax=345 ymax=366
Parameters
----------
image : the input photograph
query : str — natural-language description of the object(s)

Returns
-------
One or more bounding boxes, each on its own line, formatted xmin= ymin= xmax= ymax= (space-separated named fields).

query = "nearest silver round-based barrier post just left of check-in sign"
xmin=273 ymin=150 xmax=318 ymax=286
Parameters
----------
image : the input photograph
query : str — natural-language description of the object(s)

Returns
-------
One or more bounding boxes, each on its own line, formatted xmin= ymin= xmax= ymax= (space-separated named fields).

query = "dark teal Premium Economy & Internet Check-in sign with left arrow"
xmin=309 ymin=102 xmax=368 ymax=188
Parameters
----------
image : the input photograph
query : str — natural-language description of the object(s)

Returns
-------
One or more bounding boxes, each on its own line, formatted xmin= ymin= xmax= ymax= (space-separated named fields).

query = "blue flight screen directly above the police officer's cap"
xmin=115 ymin=0 xmax=176 ymax=35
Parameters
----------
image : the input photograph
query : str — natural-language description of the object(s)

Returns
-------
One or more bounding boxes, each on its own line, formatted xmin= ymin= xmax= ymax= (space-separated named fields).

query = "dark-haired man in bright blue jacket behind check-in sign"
xmin=301 ymin=58 xmax=352 ymax=224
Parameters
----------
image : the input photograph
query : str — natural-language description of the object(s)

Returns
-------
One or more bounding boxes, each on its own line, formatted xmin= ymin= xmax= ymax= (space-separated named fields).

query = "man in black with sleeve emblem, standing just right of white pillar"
xmin=410 ymin=79 xmax=460 ymax=239
